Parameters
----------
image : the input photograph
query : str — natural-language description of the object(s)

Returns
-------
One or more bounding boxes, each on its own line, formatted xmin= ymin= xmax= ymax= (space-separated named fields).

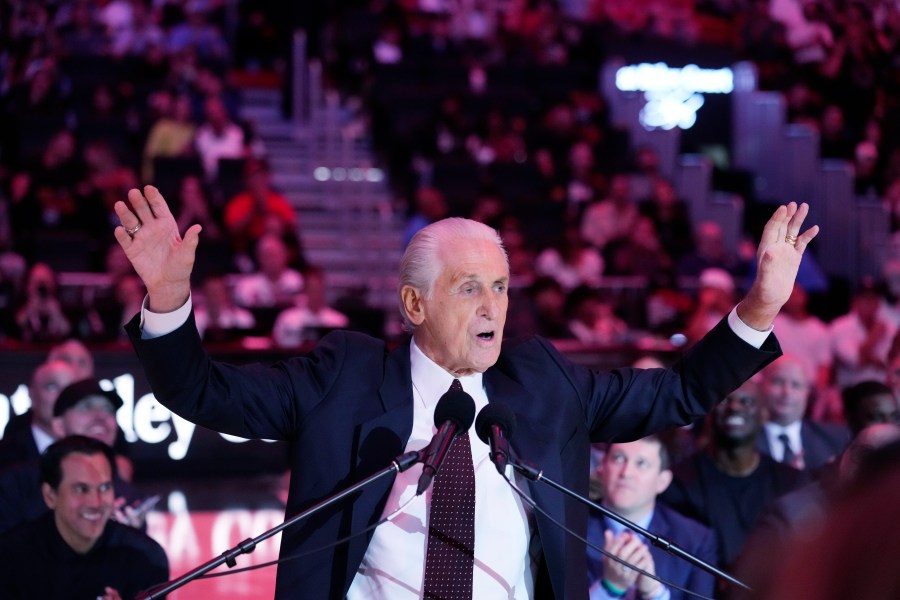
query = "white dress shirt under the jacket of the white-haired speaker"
xmin=347 ymin=341 xmax=534 ymax=600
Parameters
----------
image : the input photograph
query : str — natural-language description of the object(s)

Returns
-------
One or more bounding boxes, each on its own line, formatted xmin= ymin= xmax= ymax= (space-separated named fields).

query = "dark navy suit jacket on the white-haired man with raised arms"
xmin=126 ymin=315 xmax=780 ymax=600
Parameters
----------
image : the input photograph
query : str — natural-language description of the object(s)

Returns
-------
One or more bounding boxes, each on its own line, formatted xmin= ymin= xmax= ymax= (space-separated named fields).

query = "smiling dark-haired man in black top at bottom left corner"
xmin=0 ymin=436 xmax=169 ymax=600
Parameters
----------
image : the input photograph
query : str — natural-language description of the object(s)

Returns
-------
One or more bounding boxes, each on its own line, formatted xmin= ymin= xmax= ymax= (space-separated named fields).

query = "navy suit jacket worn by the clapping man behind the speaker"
xmin=587 ymin=502 xmax=717 ymax=600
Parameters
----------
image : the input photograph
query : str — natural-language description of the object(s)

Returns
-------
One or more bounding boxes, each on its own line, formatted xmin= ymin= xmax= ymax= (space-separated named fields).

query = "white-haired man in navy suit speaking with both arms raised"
xmin=115 ymin=186 xmax=818 ymax=600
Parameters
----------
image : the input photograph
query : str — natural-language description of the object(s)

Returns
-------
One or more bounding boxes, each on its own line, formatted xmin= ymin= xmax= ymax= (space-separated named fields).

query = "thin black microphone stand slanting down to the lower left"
xmin=135 ymin=450 xmax=424 ymax=600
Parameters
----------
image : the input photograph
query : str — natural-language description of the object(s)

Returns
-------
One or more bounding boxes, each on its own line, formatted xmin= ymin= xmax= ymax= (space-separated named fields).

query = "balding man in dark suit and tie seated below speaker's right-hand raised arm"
xmin=757 ymin=355 xmax=850 ymax=475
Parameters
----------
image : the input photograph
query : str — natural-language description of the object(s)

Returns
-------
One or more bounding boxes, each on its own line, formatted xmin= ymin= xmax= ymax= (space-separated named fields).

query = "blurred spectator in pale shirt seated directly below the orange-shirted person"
xmin=234 ymin=235 xmax=303 ymax=308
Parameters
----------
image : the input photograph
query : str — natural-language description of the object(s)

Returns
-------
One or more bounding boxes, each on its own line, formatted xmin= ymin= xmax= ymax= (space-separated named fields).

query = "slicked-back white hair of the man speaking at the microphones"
xmin=398 ymin=217 xmax=509 ymax=331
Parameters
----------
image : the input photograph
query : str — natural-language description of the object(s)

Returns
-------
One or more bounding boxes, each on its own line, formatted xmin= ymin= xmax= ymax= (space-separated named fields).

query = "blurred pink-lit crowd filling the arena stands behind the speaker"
xmin=0 ymin=0 xmax=900 ymax=390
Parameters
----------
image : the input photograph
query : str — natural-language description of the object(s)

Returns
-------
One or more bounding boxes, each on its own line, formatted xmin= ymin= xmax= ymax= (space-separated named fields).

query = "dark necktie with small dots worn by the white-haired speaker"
xmin=425 ymin=379 xmax=475 ymax=600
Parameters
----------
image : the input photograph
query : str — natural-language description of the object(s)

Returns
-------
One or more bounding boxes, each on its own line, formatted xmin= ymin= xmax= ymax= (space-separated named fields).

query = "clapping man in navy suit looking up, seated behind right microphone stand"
xmin=587 ymin=436 xmax=716 ymax=600
